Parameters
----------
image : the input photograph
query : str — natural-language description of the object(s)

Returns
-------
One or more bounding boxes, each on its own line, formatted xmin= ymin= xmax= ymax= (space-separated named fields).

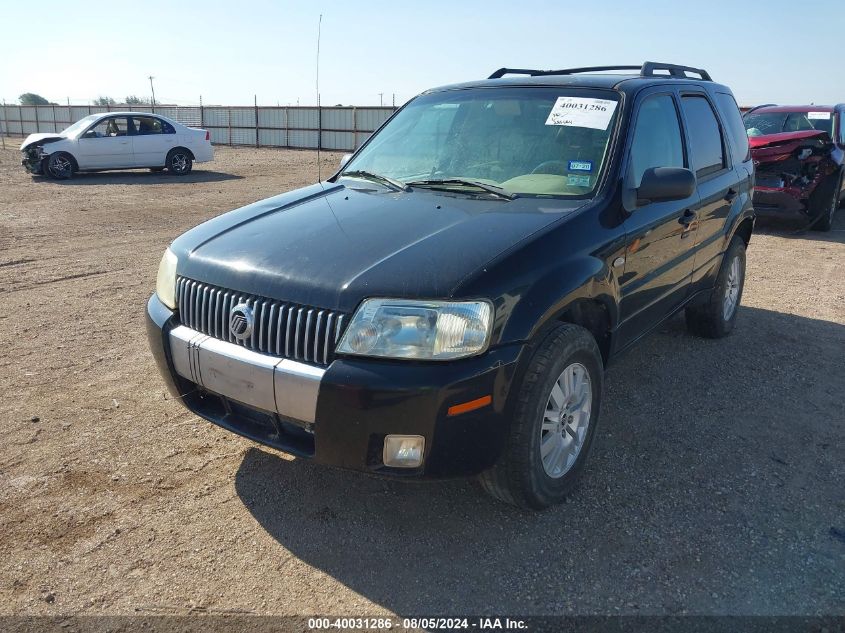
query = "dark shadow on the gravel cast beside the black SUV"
xmin=235 ymin=307 xmax=845 ymax=614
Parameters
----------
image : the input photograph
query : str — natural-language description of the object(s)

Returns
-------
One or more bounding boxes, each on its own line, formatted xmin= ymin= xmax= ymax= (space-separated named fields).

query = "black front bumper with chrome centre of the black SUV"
xmin=147 ymin=295 xmax=525 ymax=477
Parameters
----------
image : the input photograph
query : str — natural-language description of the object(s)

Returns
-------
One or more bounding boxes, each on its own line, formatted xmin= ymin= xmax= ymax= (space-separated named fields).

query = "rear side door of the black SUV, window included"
xmin=681 ymin=90 xmax=740 ymax=283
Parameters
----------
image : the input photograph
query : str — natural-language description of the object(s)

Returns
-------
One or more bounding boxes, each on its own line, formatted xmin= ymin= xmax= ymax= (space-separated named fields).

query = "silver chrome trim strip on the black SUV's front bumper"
xmin=170 ymin=325 xmax=326 ymax=423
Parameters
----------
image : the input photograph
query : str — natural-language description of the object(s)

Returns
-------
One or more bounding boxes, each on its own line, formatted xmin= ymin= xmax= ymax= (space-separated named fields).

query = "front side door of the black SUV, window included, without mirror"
xmin=619 ymin=86 xmax=699 ymax=347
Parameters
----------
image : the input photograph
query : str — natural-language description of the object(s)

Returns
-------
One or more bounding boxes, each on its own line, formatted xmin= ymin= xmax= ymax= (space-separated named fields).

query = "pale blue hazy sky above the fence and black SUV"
xmin=0 ymin=0 xmax=845 ymax=105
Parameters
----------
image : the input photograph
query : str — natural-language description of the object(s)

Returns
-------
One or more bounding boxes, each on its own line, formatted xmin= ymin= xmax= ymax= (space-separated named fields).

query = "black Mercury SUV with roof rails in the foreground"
xmin=148 ymin=62 xmax=754 ymax=508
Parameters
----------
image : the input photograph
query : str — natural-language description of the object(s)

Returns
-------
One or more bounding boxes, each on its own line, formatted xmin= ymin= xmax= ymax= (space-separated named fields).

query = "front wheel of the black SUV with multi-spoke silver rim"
xmin=479 ymin=323 xmax=604 ymax=510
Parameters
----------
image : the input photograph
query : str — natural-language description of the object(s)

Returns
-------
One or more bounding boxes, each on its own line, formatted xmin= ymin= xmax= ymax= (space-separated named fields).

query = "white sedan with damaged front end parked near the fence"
xmin=21 ymin=112 xmax=214 ymax=179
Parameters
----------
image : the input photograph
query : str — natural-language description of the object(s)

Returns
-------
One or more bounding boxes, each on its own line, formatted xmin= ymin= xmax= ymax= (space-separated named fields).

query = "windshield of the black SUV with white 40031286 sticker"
xmin=343 ymin=87 xmax=619 ymax=197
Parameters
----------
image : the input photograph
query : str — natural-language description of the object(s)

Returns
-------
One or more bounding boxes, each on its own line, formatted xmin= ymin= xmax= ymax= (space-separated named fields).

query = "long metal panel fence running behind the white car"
xmin=0 ymin=105 xmax=395 ymax=151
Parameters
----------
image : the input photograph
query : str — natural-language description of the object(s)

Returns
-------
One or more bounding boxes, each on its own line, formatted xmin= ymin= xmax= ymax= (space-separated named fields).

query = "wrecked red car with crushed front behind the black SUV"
xmin=743 ymin=104 xmax=845 ymax=231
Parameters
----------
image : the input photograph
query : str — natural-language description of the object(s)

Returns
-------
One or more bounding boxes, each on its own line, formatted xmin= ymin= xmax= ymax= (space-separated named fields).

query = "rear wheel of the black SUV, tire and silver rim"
xmin=684 ymin=235 xmax=745 ymax=338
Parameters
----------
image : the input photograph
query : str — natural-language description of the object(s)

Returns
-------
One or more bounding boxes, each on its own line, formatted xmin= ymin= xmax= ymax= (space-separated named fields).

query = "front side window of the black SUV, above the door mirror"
xmin=630 ymin=95 xmax=684 ymax=187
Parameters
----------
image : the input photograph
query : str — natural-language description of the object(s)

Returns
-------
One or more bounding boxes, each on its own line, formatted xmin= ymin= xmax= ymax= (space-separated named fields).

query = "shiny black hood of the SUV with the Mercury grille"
xmin=171 ymin=183 xmax=585 ymax=312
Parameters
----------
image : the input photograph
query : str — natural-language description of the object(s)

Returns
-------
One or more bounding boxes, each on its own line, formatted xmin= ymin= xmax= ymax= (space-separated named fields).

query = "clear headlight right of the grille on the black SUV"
xmin=337 ymin=299 xmax=493 ymax=360
